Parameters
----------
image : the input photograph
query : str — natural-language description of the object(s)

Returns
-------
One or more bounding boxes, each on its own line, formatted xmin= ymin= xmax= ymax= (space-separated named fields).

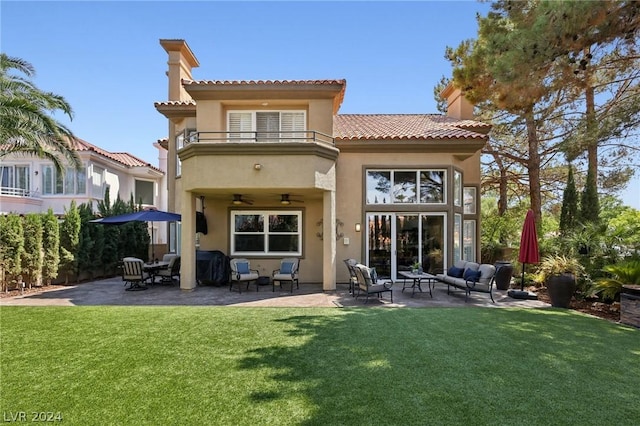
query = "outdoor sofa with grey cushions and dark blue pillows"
xmin=435 ymin=260 xmax=496 ymax=303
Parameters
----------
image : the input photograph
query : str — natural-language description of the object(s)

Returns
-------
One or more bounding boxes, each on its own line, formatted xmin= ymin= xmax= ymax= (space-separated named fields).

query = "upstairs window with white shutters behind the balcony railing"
xmin=227 ymin=111 xmax=306 ymax=142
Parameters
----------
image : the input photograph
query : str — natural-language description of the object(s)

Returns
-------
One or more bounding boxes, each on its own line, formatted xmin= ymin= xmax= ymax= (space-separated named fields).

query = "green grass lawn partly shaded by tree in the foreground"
xmin=0 ymin=307 xmax=640 ymax=426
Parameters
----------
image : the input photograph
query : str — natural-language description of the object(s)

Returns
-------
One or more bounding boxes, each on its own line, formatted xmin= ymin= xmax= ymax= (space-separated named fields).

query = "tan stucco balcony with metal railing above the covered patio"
xmin=178 ymin=131 xmax=340 ymax=193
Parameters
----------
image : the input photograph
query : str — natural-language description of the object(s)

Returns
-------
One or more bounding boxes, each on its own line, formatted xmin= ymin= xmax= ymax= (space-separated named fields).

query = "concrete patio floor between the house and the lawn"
xmin=0 ymin=277 xmax=550 ymax=308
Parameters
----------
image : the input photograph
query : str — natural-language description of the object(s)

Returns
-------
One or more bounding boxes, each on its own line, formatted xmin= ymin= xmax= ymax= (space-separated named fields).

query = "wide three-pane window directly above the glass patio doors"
xmin=366 ymin=170 xmax=445 ymax=204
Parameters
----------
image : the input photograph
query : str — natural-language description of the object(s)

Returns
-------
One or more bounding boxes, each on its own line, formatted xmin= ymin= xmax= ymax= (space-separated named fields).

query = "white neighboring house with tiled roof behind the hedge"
xmin=0 ymin=138 xmax=167 ymax=244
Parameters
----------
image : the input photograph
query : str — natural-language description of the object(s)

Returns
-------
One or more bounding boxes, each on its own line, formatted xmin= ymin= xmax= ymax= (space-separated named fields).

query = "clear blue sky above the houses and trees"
xmin=0 ymin=0 xmax=640 ymax=208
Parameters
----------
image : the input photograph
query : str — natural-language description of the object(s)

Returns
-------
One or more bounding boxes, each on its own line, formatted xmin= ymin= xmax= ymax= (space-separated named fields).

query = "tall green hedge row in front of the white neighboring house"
xmin=0 ymin=200 xmax=150 ymax=292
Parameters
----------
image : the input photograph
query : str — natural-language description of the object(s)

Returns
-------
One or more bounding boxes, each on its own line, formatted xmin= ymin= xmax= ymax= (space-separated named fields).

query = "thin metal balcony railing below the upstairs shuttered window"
xmin=185 ymin=130 xmax=335 ymax=146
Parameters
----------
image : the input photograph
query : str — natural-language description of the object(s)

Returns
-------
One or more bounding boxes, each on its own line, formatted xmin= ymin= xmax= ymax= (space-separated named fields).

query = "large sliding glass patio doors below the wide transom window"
xmin=366 ymin=213 xmax=446 ymax=279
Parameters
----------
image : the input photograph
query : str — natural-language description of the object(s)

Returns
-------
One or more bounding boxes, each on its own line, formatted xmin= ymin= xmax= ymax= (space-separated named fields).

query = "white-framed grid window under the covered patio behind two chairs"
xmin=231 ymin=211 xmax=302 ymax=256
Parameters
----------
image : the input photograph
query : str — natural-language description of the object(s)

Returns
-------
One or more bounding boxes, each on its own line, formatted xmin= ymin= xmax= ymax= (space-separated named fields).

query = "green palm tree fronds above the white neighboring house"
xmin=0 ymin=53 xmax=80 ymax=172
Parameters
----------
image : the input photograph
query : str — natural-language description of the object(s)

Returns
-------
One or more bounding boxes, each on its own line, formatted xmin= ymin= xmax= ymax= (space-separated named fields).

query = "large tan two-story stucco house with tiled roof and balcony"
xmin=155 ymin=40 xmax=490 ymax=290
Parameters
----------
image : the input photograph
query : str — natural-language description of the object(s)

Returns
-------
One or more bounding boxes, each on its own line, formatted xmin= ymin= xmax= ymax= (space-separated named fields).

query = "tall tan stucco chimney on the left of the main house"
xmin=160 ymin=39 xmax=200 ymax=101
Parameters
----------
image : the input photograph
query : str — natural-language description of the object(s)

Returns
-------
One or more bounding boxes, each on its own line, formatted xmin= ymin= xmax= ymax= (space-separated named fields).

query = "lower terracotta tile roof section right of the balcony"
xmin=333 ymin=114 xmax=491 ymax=140
